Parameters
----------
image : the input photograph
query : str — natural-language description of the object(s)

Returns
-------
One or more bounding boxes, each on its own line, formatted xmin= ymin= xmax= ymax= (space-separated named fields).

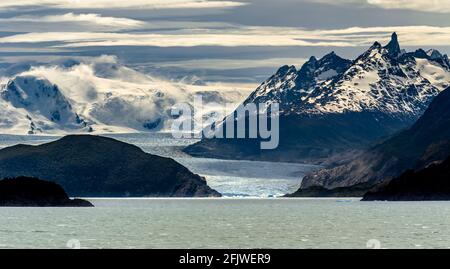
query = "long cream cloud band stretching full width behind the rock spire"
xmin=0 ymin=26 xmax=450 ymax=48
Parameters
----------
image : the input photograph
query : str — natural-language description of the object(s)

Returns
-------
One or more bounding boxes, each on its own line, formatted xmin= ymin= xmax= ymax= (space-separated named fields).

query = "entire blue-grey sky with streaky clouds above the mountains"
xmin=0 ymin=0 xmax=450 ymax=85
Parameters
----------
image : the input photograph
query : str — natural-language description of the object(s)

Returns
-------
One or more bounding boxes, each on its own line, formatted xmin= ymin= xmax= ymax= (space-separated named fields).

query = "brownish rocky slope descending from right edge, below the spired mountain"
xmin=294 ymin=88 xmax=450 ymax=196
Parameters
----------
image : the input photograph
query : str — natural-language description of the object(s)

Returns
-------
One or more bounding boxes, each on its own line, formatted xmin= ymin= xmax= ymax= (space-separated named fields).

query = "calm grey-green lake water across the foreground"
xmin=0 ymin=198 xmax=450 ymax=248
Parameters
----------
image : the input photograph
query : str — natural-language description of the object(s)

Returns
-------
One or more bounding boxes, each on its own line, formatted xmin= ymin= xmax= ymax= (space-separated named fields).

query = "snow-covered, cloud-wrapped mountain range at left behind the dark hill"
xmin=0 ymin=56 xmax=250 ymax=134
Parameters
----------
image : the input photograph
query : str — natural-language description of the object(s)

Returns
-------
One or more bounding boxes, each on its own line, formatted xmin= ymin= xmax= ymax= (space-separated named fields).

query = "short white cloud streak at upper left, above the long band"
xmin=0 ymin=13 xmax=145 ymax=29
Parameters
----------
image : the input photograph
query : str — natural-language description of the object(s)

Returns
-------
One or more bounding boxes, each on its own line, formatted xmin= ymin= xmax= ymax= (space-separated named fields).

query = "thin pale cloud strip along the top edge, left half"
xmin=0 ymin=0 xmax=245 ymax=9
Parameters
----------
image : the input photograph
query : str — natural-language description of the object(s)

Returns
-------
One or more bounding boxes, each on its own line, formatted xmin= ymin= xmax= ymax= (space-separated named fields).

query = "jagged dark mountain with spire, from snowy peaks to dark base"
xmin=186 ymin=33 xmax=450 ymax=161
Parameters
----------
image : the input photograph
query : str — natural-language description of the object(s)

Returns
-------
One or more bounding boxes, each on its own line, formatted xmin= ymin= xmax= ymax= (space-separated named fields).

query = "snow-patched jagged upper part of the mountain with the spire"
xmin=246 ymin=33 xmax=450 ymax=117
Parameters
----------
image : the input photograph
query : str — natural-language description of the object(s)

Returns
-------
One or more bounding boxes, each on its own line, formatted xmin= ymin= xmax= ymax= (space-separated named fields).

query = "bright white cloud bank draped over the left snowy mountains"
xmin=0 ymin=55 xmax=251 ymax=133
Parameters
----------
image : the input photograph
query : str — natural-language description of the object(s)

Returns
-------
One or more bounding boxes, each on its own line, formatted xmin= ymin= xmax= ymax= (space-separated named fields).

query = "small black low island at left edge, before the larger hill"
xmin=0 ymin=177 xmax=94 ymax=207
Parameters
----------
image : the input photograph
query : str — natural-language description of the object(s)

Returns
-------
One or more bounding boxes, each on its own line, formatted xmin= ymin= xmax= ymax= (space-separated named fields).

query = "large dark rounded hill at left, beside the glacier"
xmin=0 ymin=135 xmax=221 ymax=197
